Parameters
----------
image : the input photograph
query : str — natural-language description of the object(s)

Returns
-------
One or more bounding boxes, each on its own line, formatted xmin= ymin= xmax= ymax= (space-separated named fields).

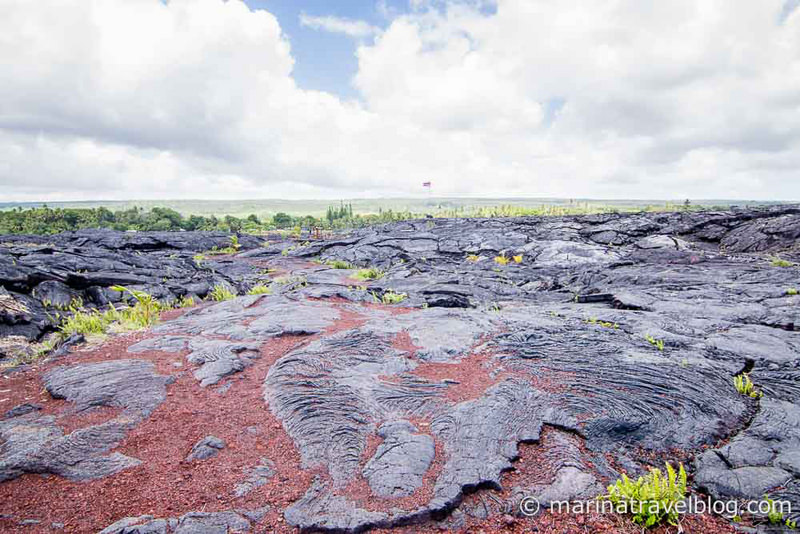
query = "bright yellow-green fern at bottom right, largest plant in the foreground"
xmin=600 ymin=463 xmax=686 ymax=528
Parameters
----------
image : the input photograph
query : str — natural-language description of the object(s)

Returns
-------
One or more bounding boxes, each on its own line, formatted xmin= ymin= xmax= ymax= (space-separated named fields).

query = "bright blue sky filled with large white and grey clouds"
xmin=0 ymin=0 xmax=800 ymax=200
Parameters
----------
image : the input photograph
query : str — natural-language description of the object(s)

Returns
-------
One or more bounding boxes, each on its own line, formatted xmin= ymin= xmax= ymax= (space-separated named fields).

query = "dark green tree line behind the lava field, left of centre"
xmin=0 ymin=203 xmax=418 ymax=235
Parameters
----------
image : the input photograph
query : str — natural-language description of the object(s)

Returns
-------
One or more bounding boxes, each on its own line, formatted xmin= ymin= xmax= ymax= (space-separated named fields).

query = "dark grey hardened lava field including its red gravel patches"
xmin=0 ymin=206 xmax=800 ymax=534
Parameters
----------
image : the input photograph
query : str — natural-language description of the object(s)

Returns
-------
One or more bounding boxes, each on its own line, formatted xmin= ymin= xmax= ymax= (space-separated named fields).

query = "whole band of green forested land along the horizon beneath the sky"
xmin=0 ymin=198 xmax=770 ymax=235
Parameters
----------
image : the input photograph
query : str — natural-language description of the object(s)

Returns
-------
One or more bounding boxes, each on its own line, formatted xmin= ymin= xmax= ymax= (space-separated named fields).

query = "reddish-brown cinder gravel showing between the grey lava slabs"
xmin=0 ymin=306 xmax=733 ymax=534
